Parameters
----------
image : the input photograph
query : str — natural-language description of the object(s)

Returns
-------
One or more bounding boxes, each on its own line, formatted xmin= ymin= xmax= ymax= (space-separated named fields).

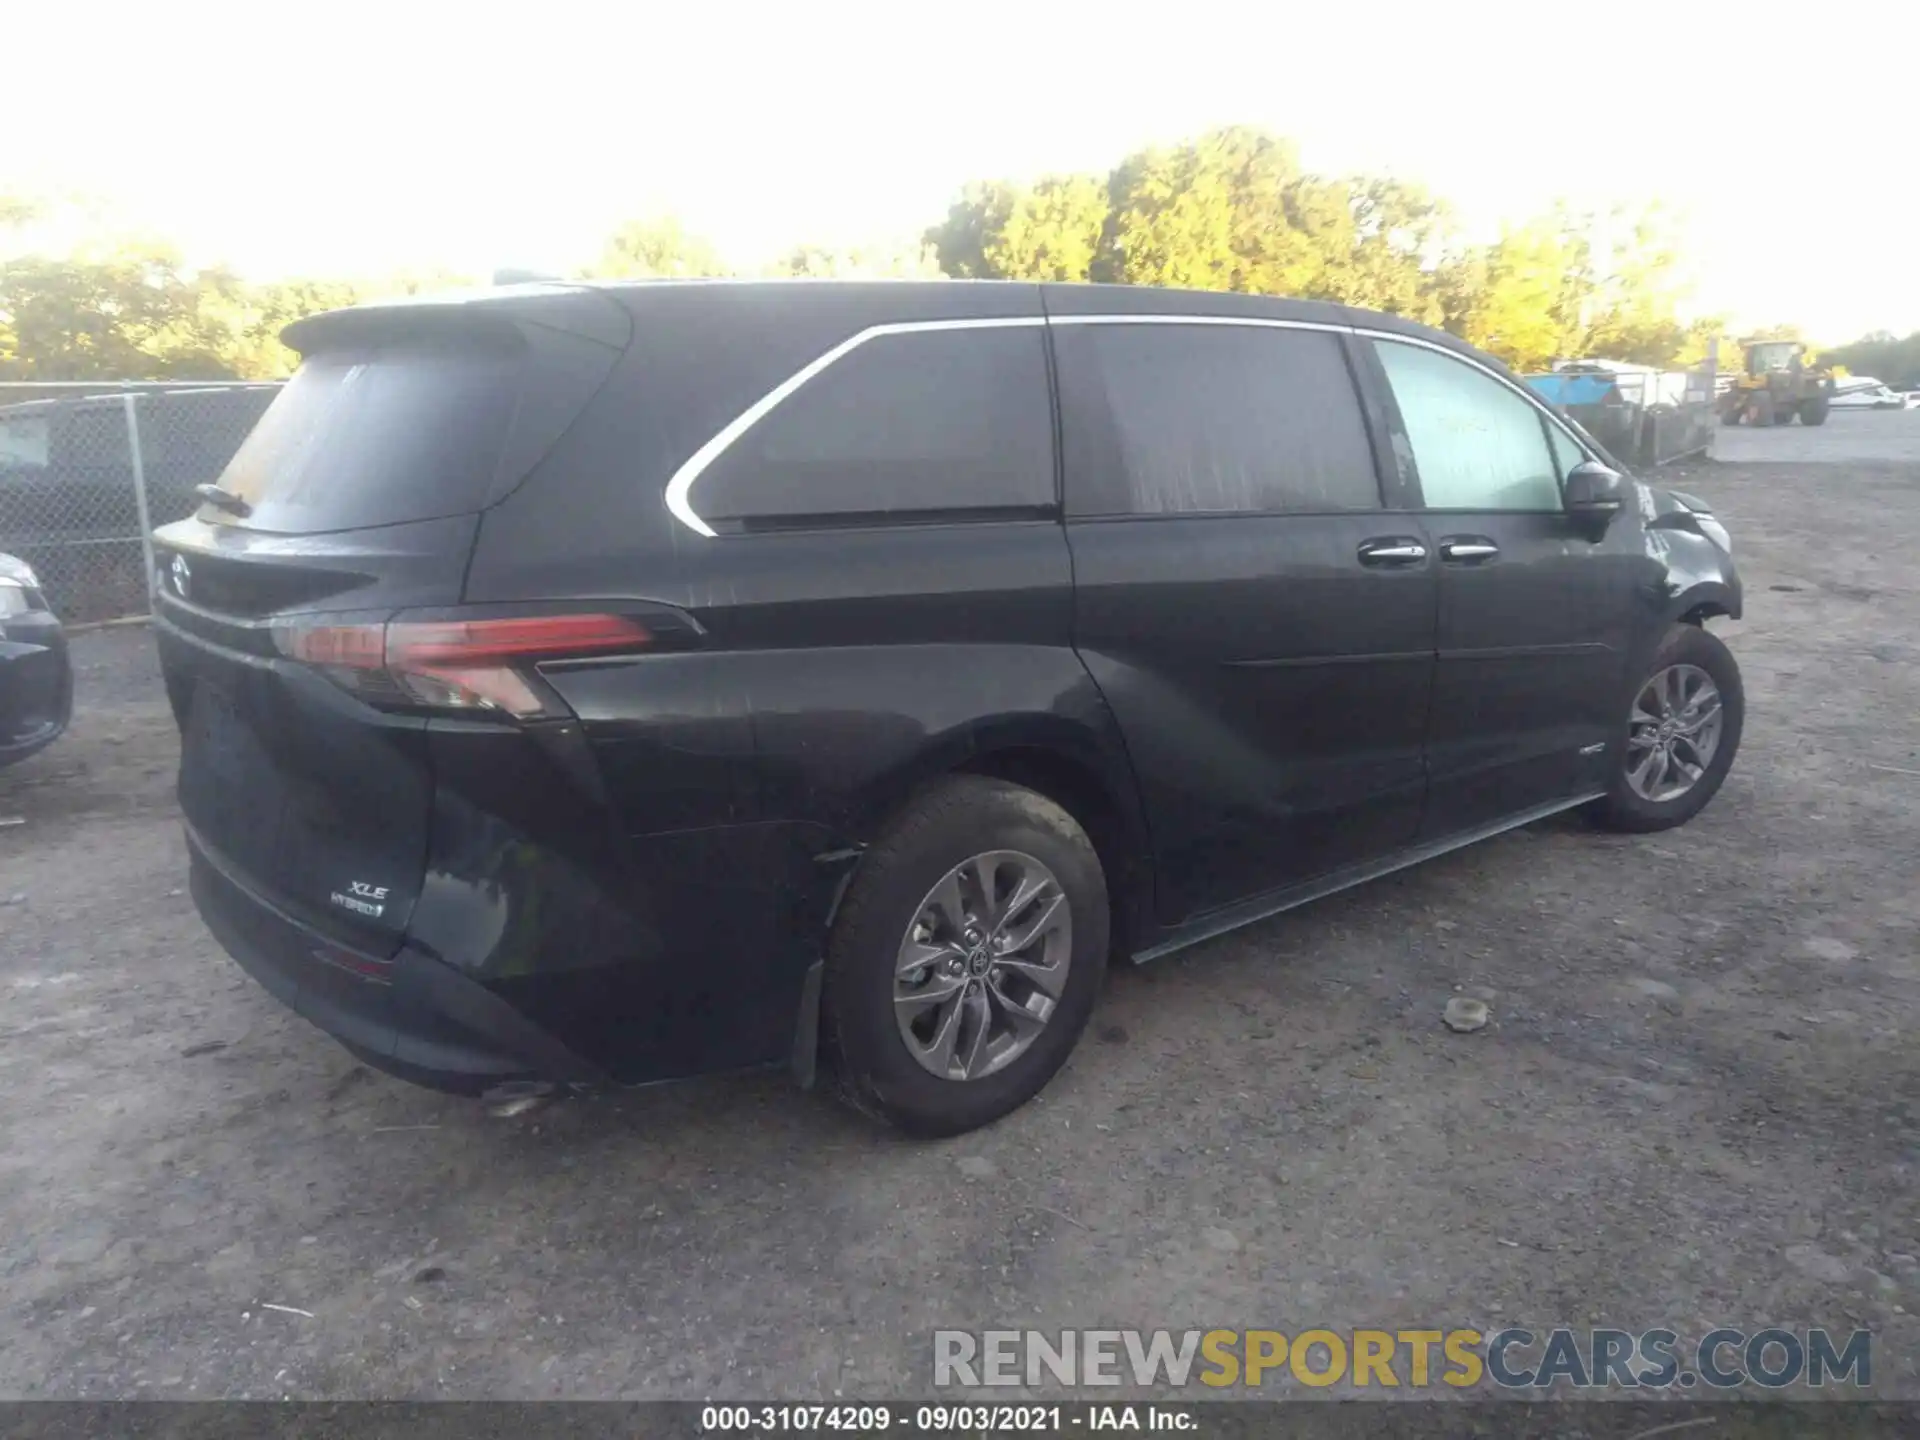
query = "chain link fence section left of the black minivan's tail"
xmin=0 ymin=382 xmax=280 ymax=620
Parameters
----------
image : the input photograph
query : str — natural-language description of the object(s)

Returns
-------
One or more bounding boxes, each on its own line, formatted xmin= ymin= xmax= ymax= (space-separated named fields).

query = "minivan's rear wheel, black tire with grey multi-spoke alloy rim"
xmin=824 ymin=776 xmax=1110 ymax=1137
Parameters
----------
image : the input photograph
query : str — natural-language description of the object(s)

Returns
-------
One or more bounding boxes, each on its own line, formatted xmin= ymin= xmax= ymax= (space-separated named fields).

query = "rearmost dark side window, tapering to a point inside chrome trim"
xmin=687 ymin=324 xmax=1054 ymax=524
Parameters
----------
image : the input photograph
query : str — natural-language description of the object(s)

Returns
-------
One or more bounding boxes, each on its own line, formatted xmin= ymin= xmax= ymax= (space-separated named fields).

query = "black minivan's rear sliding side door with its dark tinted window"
xmin=1052 ymin=313 xmax=1436 ymax=924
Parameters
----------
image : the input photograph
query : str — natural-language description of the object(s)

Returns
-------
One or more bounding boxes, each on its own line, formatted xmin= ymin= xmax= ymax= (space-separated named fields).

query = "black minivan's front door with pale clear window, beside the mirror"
xmin=1373 ymin=338 xmax=1638 ymax=841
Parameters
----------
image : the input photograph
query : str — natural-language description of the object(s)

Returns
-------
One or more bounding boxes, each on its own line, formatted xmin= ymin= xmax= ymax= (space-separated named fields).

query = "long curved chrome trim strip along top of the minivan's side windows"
xmin=666 ymin=313 xmax=1594 ymax=536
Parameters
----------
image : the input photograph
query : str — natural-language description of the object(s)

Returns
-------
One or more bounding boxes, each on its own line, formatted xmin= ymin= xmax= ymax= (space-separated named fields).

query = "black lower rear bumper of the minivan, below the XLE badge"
xmin=186 ymin=831 xmax=605 ymax=1094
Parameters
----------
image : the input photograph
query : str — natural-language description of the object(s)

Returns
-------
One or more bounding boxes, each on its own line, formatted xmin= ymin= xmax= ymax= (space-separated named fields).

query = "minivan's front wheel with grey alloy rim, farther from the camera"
xmin=1592 ymin=624 xmax=1747 ymax=831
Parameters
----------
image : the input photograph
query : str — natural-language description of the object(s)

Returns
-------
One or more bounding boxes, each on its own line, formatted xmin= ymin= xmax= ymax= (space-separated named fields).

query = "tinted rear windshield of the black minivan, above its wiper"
xmin=219 ymin=342 xmax=528 ymax=532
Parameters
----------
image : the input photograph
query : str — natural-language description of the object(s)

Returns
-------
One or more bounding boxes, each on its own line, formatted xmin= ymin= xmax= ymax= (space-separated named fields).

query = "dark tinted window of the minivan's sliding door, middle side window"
xmin=1054 ymin=323 xmax=1380 ymax=515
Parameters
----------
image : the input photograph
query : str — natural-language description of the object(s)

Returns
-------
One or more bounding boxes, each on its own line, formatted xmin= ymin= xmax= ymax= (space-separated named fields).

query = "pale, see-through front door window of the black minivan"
xmin=1375 ymin=340 xmax=1561 ymax=511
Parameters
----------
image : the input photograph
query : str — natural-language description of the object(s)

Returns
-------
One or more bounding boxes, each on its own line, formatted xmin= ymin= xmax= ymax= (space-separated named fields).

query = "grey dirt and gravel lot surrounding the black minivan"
xmin=0 ymin=426 xmax=1920 ymax=1398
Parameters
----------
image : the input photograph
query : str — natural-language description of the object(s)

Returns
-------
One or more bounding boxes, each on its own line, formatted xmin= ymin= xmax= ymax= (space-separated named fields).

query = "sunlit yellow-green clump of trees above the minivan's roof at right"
xmin=927 ymin=138 xmax=1751 ymax=369
